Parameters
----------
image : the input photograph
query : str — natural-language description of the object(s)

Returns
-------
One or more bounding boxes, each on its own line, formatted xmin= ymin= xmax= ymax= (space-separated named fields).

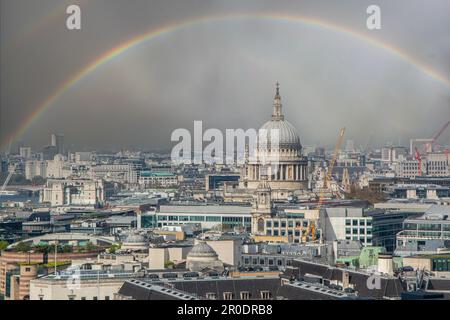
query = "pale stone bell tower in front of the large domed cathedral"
xmin=252 ymin=175 xmax=273 ymax=235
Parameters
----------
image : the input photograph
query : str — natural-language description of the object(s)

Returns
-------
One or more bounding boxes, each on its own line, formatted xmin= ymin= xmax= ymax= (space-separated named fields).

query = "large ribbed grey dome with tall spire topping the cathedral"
xmin=259 ymin=83 xmax=302 ymax=150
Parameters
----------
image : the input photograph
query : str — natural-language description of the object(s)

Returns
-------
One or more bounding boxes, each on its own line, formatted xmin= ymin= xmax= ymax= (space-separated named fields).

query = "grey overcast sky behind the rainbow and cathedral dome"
xmin=0 ymin=0 xmax=450 ymax=150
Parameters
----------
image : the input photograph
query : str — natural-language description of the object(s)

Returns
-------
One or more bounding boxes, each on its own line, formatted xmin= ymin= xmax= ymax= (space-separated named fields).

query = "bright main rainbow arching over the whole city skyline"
xmin=1 ymin=13 xmax=450 ymax=146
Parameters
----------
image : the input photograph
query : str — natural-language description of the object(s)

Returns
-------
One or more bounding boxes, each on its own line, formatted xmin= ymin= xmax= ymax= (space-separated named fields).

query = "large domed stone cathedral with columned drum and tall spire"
xmin=242 ymin=84 xmax=308 ymax=199
